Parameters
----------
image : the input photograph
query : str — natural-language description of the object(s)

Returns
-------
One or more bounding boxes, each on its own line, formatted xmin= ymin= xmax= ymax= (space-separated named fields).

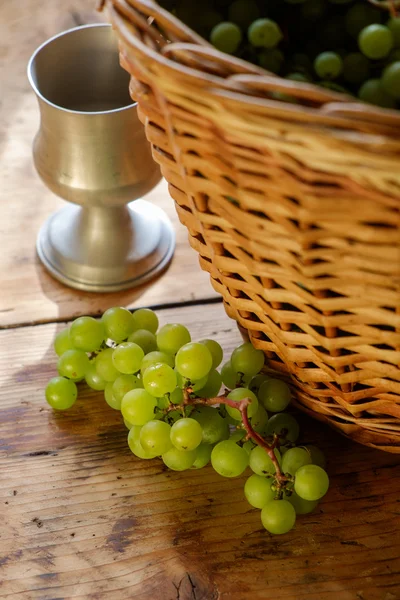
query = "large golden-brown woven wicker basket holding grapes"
xmin=107 ymin=0 xmax=400 ymax=452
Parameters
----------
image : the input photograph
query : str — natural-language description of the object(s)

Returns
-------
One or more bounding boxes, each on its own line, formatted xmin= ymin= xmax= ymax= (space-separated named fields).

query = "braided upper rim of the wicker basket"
xmin=104 ymin=0 xmax=400 ymax=132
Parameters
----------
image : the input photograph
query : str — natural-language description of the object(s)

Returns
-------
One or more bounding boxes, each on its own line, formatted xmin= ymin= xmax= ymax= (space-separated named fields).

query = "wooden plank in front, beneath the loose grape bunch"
xmin=0 ymin=305 xmax=400 ymax=600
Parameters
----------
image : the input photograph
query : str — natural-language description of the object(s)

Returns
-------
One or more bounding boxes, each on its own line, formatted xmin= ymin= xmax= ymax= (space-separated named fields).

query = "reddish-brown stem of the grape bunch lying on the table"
xmin=172 ymin=387 xmax=289 ymax=488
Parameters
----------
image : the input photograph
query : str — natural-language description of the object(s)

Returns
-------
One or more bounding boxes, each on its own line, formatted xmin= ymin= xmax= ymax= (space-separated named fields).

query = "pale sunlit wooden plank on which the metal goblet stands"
xmin=0 ymin=0 xmax=216 ymax=327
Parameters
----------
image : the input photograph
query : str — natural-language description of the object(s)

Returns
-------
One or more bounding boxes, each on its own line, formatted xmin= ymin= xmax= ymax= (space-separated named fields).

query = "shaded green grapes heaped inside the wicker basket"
xmin=158 ymin=0 xmax=400 ymax=109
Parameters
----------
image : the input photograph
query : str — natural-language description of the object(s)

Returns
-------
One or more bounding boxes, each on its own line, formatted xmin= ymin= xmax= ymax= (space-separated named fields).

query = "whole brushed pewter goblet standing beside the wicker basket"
xmin=28 ymin=24 xmax=175 ymax=292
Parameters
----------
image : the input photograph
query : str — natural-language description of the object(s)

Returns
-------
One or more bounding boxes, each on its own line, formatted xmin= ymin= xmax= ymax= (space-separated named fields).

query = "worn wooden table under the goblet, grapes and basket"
xmin=0 ymin=0 xmax=400 ymax=600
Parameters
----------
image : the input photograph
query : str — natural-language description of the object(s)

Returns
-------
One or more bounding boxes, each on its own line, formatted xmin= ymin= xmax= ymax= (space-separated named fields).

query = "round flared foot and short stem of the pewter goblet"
xmin=36 ymin=200 xmax=175 ymax=292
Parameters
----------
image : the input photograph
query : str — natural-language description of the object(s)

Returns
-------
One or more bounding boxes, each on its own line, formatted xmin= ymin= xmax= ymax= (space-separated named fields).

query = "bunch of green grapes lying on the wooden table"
xmin=45 ymin=307 xmax=329 ymax=534
